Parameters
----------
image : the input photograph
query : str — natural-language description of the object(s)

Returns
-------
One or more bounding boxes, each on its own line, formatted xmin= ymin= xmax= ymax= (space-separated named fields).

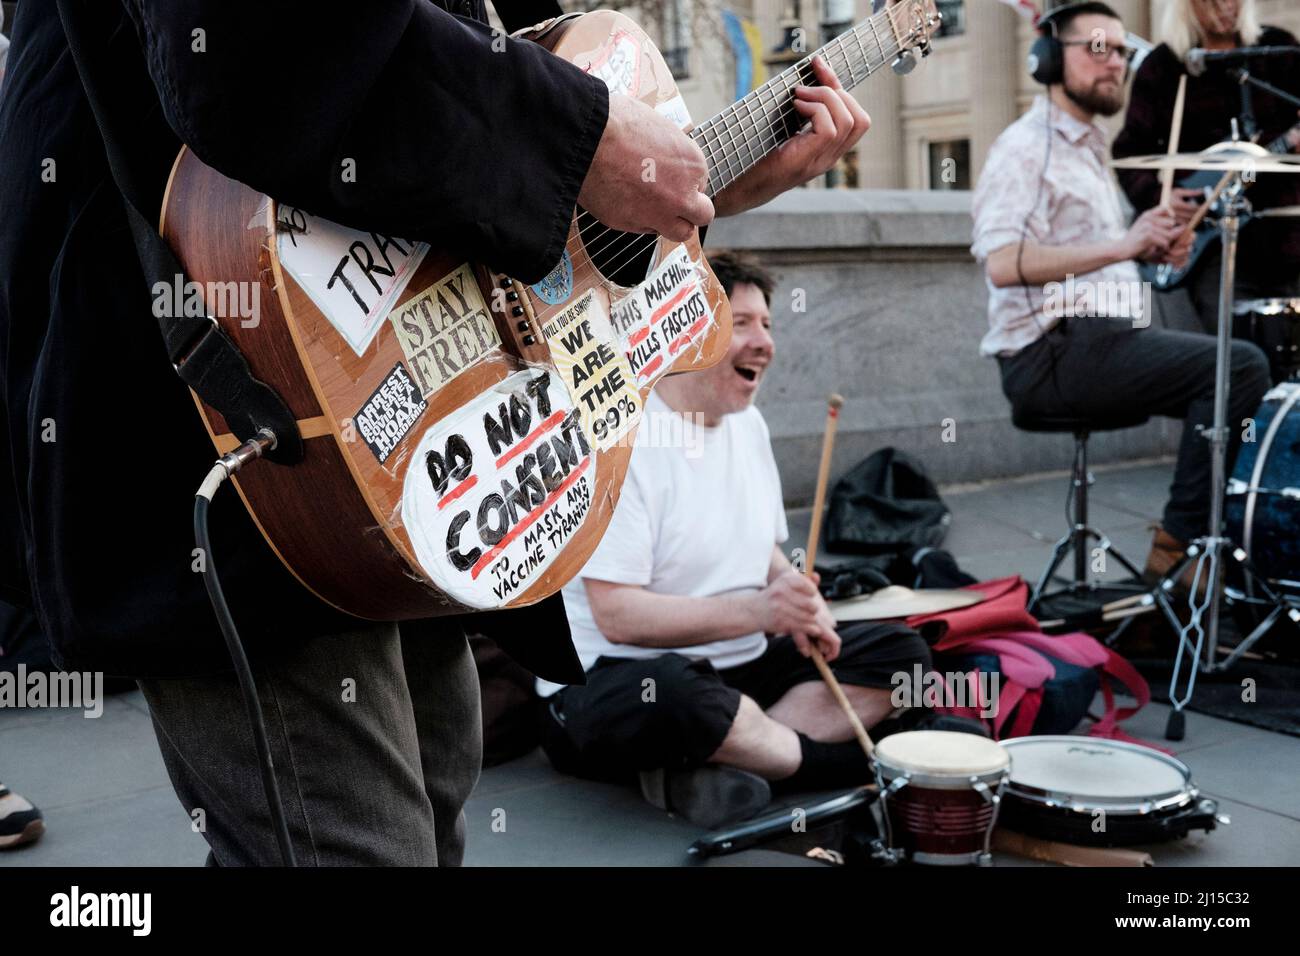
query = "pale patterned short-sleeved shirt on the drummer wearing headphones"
xmin=971 ymin=95 xmax=1143 ymax=355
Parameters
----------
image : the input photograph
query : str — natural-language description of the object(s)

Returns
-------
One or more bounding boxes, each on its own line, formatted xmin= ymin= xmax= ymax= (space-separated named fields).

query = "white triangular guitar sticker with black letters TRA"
xmin=276 ymin=206 xmax=429 ymax=355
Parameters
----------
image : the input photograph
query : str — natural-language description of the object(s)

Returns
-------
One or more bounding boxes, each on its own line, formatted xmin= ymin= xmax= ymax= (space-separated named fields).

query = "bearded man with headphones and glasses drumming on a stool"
xmin=971 ymin=3 xmax=1269 ymax=585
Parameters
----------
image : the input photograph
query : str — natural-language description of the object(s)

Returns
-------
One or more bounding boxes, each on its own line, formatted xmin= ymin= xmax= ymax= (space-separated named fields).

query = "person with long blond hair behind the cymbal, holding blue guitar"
xmin=1113 ymin=0 xmax=1300 ymax=332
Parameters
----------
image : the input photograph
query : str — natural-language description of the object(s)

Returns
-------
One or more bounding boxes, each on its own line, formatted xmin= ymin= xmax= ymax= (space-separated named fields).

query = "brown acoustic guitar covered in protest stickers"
xmin=160 ymin=0 xmax=939 ymax=620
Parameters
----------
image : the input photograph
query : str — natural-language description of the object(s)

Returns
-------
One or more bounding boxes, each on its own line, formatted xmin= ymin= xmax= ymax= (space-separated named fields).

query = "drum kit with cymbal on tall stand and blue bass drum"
xmin=1112 ymin=136 xmax=1300 ymax=740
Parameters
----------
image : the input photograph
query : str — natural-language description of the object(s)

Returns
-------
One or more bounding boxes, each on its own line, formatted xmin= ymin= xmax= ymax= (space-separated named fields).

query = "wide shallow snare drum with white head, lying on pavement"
xmin=1000 ymin=736 xmax=1218 ymax=847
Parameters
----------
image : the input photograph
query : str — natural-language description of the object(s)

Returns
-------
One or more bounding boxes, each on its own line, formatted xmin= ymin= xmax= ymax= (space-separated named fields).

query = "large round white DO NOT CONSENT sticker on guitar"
xmin=402 ymin=371 xmax=595 ymax=609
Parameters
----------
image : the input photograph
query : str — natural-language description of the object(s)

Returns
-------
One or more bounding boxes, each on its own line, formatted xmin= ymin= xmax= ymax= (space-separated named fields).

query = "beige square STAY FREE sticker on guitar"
xmin=389 ymin=263 xmax=501 ymax=397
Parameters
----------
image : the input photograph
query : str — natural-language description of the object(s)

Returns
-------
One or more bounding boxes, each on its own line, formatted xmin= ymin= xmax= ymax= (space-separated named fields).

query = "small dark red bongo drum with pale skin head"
xmin=876 ymin=730 xmax=1011 ymax=866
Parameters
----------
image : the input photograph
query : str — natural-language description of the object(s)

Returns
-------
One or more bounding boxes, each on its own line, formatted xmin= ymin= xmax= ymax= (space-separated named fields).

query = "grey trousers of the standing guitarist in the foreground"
xmin=140 ymin=620 xmax=482 ymax=866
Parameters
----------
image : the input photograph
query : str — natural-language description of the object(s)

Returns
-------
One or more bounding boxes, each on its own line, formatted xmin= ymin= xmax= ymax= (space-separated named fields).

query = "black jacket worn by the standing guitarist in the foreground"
xmin=0 ymin=0 xmax=608 ymax=680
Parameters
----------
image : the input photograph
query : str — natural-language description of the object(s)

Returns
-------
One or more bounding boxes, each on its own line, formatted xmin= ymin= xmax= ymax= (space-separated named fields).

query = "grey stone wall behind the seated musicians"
xmin=707 ymin=190 xmax=1182 ymax=506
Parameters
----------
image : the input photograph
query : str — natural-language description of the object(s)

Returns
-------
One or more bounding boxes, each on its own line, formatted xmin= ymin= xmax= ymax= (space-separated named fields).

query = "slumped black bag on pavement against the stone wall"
xmin=826 ymin=447 xmax=953 ymax=554
